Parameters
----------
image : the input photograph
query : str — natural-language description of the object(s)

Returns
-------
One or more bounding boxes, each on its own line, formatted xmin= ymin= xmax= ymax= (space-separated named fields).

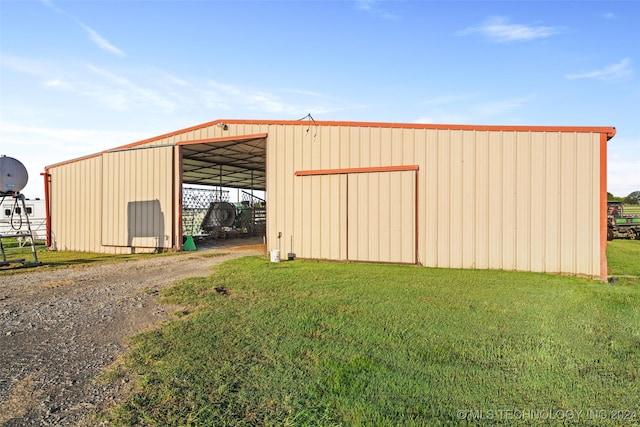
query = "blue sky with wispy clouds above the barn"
xmin=0 ymin=0 xmax=640 ymax=198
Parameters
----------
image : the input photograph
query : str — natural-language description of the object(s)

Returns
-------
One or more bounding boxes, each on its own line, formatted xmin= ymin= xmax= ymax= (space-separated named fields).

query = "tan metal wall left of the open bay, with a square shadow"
xmin=49 ymin=147 xmax=177 ymax=254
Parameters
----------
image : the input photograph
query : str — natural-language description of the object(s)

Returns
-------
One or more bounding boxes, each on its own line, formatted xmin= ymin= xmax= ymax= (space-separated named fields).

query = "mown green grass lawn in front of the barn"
xmin=100 ymin=246 xmax=640 ymax=426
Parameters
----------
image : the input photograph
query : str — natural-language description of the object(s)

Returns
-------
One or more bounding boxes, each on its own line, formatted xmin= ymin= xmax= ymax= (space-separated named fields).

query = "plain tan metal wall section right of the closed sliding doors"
xmin=419 ymin=131 xmax=600 ymax=276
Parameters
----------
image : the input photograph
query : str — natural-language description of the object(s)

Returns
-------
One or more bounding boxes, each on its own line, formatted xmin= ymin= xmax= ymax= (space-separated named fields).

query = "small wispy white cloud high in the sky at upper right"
xmin=456 ymin=16 xmax=564 ymax=43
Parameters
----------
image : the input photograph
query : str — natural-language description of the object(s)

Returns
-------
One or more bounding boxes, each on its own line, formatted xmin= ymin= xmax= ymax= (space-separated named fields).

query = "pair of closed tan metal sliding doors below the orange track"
xmin=290 ymin=171 xmax=417 ymax=263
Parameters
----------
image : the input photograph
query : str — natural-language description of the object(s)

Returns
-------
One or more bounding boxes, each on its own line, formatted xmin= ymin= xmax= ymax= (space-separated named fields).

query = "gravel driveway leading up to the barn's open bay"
xmin=0 ymin=242 xmax=264 ymax=426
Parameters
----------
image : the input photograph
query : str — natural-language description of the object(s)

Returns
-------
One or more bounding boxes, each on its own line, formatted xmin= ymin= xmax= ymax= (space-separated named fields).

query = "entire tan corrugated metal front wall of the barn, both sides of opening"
xmin=45 ymin=121 xmax=603 ymax=276
